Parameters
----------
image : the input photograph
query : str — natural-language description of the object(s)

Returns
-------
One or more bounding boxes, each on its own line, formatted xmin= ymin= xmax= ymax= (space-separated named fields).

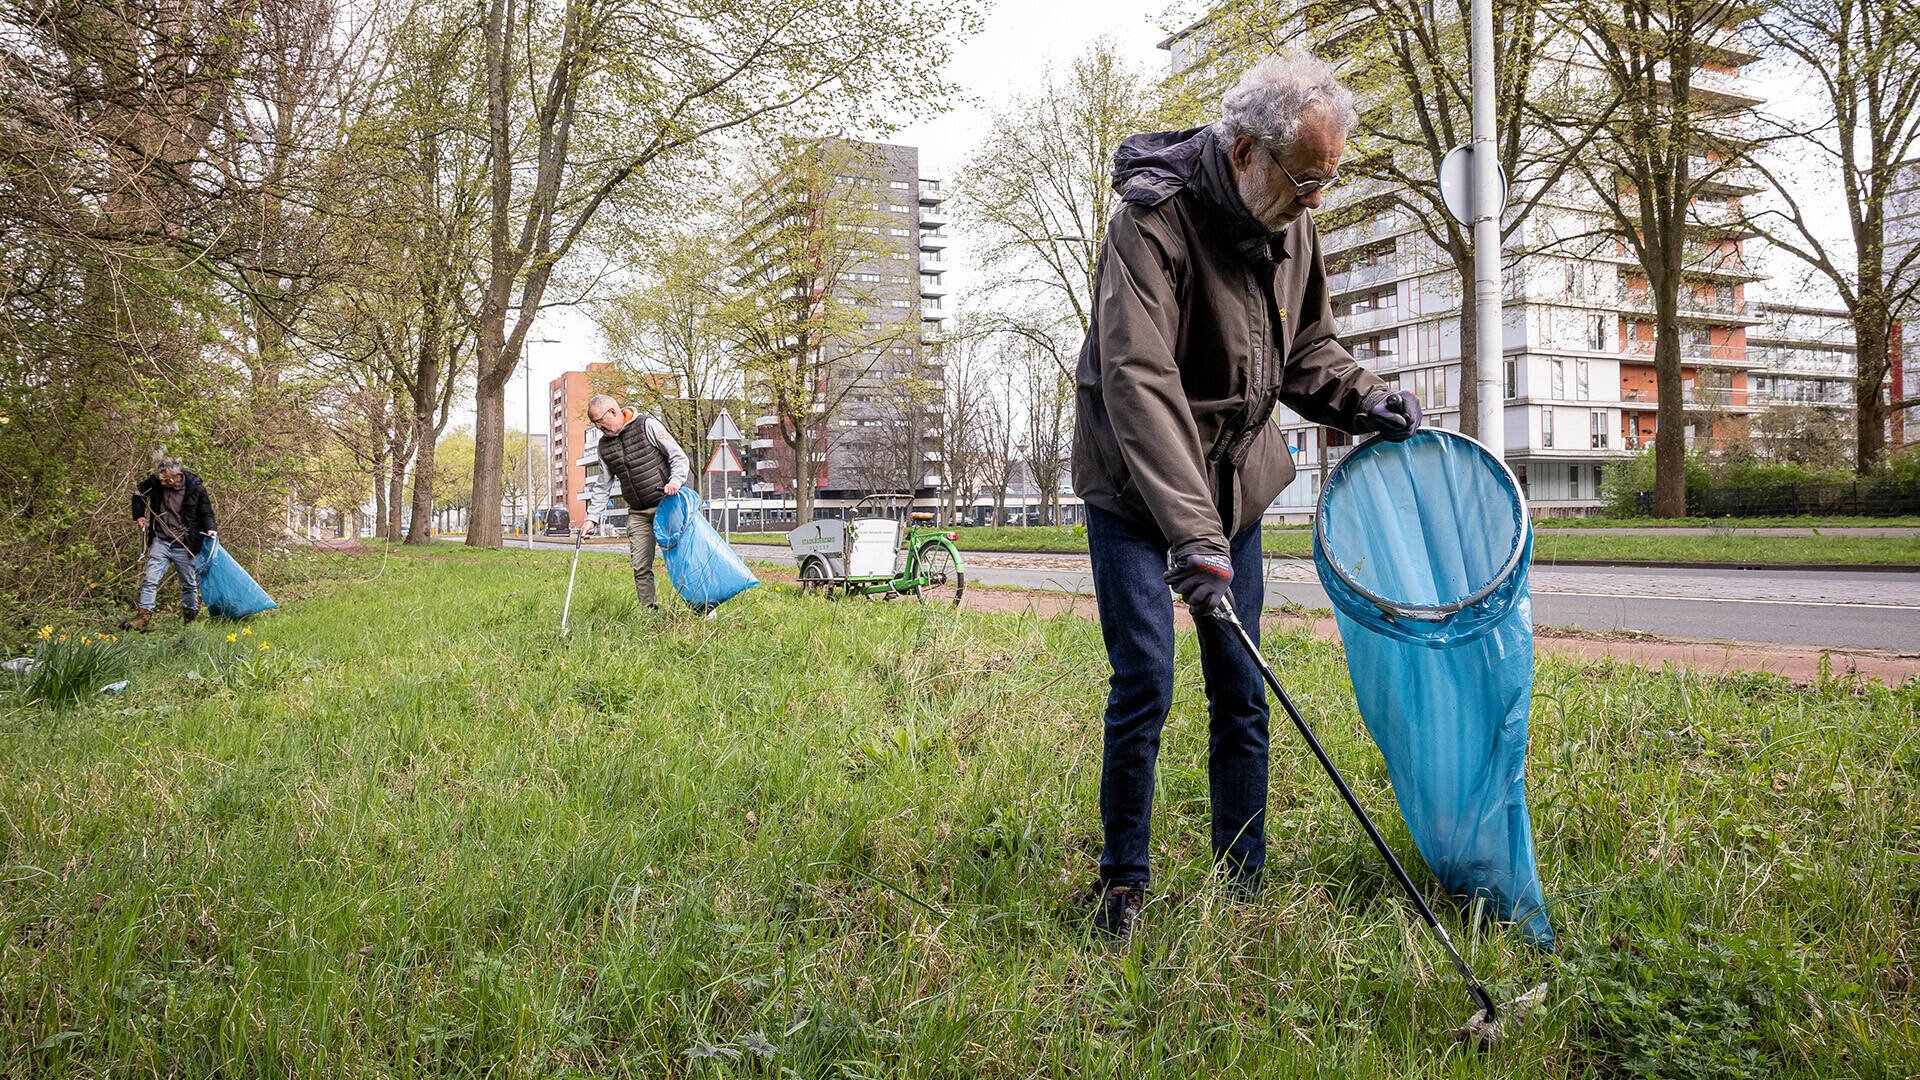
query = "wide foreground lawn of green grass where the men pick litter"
xmin=0 ymin=548 xmax=1920 ymax=1080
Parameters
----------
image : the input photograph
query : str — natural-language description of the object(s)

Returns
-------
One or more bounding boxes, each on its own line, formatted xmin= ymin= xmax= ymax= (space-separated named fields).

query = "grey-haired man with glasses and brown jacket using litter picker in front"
xmin=1073 ymin=54 xmax=1421 ymax=938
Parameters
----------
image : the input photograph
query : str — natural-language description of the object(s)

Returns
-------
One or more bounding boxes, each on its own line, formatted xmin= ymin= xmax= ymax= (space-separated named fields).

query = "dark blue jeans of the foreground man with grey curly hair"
xmin=1087 ymin=505 xmax=1267 ymax=888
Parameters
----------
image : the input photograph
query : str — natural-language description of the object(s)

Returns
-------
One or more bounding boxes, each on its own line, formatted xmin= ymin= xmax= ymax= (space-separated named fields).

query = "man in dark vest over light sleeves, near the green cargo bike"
xmin=582 ymin=394 xmax=687 ymax=611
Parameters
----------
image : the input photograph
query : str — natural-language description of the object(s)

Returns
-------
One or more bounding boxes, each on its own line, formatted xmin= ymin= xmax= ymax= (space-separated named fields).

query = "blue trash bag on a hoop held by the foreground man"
xmin=1313 ymin=429 xmax=1553 ymax=947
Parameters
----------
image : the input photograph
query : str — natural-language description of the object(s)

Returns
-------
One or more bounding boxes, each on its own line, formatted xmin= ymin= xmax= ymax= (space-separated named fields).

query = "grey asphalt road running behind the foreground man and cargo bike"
xmin=509 ymin=542 xmax=1920 ymax=651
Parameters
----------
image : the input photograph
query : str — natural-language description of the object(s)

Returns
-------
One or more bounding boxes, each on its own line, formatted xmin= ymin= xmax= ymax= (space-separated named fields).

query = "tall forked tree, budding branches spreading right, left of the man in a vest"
xmin=467 ymin=0 xmax=979 ymax=548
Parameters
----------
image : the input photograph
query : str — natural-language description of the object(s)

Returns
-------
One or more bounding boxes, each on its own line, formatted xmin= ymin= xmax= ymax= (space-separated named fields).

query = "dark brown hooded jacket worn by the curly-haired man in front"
xmin=1073 ymin=127 xmax=1388 ymax=555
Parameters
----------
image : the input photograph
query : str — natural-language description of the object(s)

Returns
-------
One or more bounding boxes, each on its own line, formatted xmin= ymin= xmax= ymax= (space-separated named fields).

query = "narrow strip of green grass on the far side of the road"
xmin=732 ymin=525 xmax=1920 ymax=567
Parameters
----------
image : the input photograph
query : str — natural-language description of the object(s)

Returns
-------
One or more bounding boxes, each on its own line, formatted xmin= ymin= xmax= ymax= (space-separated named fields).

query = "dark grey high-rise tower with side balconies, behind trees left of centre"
xmin=741 ymin=140 xmax=948 ymax=507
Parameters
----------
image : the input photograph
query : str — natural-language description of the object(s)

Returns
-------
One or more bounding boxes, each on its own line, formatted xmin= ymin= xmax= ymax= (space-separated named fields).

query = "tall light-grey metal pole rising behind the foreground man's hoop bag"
xmin=1469 ymin=0 xmax=1507 ymax=457
